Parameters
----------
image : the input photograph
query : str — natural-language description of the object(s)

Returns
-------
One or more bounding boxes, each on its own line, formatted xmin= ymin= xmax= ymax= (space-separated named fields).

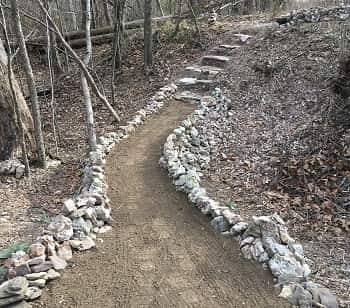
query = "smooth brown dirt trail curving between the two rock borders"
xmin=35 ymin=103 xmax=289 ymax=308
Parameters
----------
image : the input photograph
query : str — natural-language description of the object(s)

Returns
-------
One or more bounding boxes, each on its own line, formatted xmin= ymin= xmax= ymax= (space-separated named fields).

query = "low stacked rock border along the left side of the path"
xmin=0 ymin=84 xmax=177 ymax=307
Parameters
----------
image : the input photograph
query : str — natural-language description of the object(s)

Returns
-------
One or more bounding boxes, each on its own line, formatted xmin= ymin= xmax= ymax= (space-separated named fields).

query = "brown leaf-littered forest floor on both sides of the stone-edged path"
xmin=0 ymin=12 xmax=350 ymax=307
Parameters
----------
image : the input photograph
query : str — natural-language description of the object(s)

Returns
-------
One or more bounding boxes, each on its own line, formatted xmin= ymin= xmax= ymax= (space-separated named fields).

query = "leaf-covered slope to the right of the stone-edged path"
xmin=205 ymin=23 xmax=350 ymax=307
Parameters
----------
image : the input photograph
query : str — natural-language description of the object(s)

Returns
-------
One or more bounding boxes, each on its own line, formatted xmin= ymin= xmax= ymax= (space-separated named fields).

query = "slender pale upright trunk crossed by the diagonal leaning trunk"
xmin=81 ymin=0 xmax=96 ymax=151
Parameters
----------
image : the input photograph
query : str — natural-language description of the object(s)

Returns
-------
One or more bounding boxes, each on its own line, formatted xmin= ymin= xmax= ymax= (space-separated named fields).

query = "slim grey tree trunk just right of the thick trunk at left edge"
xmin=11 ymin=0 xmax=47 ymax=168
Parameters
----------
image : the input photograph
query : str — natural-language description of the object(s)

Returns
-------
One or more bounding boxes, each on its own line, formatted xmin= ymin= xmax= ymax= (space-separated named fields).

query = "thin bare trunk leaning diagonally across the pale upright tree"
xmin=34 ymin=0 xmax=120 ymax=122
